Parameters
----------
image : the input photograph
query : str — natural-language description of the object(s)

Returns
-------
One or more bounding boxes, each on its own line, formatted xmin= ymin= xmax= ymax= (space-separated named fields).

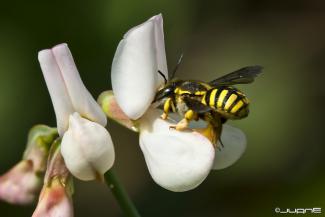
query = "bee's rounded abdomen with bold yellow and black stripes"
xmin=202 ymin=86 xmax=249 ymax=119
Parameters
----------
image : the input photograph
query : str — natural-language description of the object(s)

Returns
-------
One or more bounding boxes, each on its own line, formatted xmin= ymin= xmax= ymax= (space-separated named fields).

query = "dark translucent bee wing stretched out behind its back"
xmin=209 ymin=66 xmax=263 ymax=87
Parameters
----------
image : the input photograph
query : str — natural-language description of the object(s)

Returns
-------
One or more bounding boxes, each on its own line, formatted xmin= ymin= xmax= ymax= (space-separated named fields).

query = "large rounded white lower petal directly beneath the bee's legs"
xmin=140 ymin=111 xmax=215 ymax=192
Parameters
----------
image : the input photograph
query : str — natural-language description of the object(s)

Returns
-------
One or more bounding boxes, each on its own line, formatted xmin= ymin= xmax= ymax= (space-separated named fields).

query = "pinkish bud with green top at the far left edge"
xmin=0 ymin=125 xmax=57 ymax=204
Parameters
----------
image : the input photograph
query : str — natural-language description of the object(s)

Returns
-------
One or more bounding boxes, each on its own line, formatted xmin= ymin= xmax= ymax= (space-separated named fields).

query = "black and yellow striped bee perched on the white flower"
xmin=154 ymin=66 xmax=262 ymax=136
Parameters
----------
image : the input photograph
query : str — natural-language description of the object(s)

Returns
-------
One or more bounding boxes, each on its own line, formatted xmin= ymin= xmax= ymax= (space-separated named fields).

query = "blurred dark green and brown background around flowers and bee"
xmin=0 ymin=0 xmax=325 ymax=217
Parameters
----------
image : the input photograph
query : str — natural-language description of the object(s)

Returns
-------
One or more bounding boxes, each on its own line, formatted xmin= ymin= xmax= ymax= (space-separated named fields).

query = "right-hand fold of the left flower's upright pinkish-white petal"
xmin=52 ymin=44 xmax=107 ymax=126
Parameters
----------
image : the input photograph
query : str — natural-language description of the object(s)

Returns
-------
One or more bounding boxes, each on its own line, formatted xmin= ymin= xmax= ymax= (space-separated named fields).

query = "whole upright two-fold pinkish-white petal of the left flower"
xmin=38 ymin=44 xmax=107 ymax=137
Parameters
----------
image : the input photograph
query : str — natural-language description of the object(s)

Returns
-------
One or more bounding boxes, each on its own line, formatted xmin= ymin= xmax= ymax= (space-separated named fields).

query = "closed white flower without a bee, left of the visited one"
xmin=38 ymin=44 xmax=115 ymax=180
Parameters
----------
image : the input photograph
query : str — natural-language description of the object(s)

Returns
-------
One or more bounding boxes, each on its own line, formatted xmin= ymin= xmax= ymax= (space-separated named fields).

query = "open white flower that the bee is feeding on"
xmin=109 ymin=15 xmax=246 ymax=192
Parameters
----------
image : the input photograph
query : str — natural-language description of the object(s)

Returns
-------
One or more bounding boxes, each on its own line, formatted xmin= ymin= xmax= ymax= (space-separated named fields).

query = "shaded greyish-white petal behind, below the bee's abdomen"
xmin=213 ymin=124 xmax=246 ymax=170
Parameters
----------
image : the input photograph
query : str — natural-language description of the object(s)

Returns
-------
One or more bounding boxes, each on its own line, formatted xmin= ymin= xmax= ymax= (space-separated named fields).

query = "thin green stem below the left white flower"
xmin=105 ymin=169 xmax=140 ymax=217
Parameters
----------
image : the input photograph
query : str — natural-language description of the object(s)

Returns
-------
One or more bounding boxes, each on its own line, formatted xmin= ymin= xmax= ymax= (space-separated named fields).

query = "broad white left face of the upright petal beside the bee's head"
xmin=111 ymin=16 xmax=158 ymax=120
